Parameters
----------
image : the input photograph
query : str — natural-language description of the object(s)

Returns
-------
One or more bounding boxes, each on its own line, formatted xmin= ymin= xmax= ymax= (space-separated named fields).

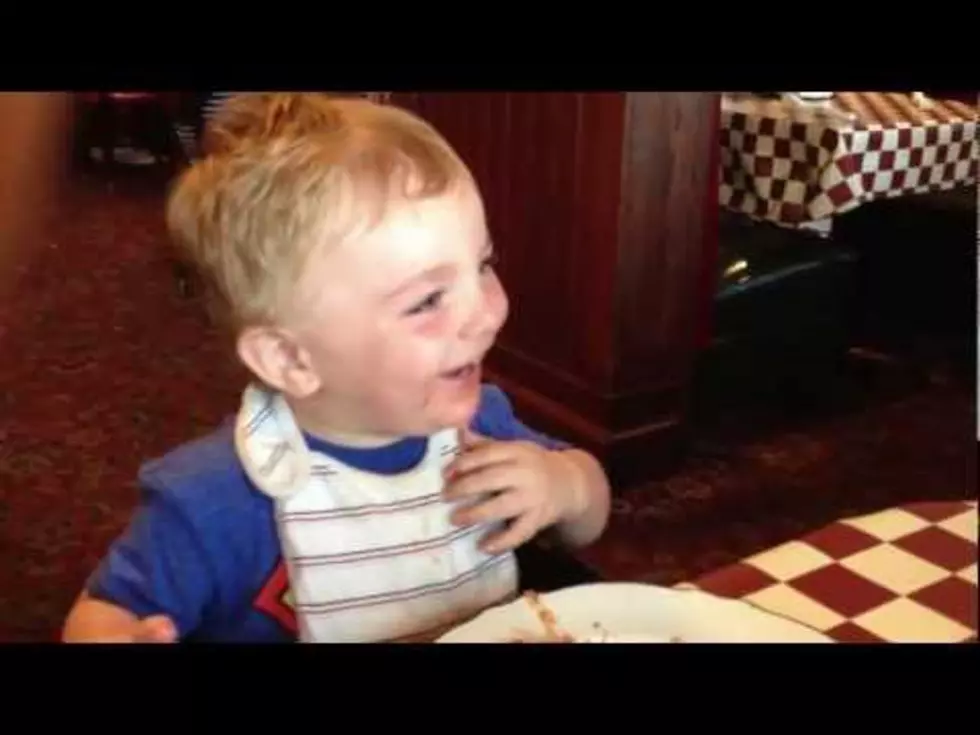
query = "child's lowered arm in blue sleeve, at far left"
xmin=62 ymin=494 xmax=214 ymax=643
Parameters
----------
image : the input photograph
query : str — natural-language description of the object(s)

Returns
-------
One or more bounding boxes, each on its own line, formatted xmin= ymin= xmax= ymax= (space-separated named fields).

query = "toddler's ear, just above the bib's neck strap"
xmin=236 ymin=326 xmax=320 ymax=398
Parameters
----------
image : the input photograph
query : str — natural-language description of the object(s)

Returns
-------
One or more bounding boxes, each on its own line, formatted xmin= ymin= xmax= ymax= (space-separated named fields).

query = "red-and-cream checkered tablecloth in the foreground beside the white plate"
xmin=678 ymin=501 xmax=978 ymax=643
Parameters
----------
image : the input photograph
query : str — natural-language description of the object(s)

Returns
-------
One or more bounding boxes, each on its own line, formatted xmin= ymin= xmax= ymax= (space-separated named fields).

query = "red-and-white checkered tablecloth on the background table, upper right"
xmin=719 ymin=92 xmax=978 ymax=226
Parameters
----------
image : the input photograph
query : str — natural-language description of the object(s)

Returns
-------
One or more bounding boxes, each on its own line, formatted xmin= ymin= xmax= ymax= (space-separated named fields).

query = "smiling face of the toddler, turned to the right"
xmin=297 ymin=184 xmax=508 ymax=438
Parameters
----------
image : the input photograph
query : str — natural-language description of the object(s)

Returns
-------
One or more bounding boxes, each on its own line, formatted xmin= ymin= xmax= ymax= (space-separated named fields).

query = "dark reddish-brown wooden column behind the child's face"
xmin=392 ymin=92 xmax=719 ymax=484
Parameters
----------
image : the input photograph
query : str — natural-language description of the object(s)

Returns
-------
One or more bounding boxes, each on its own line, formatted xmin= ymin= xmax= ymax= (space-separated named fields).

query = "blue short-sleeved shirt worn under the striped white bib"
xmin=87 ymin=386 xmax=564 ymax=643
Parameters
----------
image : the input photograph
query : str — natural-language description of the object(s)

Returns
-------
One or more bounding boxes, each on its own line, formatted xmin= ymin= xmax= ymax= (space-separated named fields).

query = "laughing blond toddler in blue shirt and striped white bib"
xmin=63 ymin=94 xmax=609 ymax=642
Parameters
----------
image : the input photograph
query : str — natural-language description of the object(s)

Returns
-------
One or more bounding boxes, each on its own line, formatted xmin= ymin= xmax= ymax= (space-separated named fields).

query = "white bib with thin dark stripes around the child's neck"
xmin=235 ymin=386 xmax=518 ymax=643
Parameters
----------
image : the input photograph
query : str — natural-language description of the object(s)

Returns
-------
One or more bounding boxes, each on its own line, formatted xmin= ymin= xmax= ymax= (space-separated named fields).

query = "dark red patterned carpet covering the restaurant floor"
xmin=0 ymin=170 xmax=976 ymax=641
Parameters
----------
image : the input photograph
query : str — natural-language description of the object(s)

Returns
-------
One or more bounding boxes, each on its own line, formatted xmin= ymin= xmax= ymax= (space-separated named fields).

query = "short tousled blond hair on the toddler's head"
xmin=167 ymin=93 xmax=472 ymax=331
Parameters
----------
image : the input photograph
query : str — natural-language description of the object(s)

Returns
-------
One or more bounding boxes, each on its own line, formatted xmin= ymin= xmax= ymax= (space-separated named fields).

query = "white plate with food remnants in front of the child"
xmin=438 ymin=582 xmax=831 ymax=643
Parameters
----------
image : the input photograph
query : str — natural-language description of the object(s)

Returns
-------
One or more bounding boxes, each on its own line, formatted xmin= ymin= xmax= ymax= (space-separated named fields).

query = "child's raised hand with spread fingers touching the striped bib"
xmin=445 ymin=433 xmax=582 ymax=554
